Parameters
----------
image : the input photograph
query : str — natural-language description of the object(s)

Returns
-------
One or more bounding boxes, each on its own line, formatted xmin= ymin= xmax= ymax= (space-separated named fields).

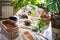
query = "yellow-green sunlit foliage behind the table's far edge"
xmin=11 ymin=0 xmax=45 ymax=11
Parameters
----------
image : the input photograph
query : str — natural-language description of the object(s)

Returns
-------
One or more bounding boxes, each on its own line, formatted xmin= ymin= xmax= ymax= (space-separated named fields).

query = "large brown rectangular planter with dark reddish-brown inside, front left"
xmin=1 ymin=20 xmax=19 ymax=39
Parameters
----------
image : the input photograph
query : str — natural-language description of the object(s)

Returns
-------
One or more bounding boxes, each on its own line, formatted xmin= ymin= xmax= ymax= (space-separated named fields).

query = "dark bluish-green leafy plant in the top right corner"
xmin=44 ymin=0 xmax=60 ymax=15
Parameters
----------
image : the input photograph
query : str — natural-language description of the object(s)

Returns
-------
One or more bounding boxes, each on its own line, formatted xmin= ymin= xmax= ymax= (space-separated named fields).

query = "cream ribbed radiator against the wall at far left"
xmin=1 ymin=1 xmax=13 ymax=18
